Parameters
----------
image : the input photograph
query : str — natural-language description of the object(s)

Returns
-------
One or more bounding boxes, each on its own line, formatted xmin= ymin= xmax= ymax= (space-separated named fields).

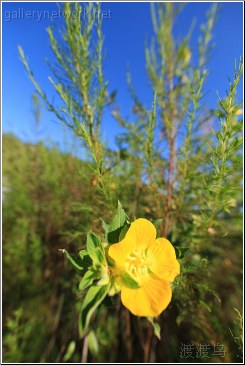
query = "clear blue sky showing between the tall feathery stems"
xmin=2 ymin=2 xmax=243 ymax=149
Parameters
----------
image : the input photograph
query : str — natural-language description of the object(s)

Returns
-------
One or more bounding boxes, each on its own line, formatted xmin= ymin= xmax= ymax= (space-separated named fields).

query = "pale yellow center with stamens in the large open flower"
xmin=126 ymin=249 xmax=148 ymax=282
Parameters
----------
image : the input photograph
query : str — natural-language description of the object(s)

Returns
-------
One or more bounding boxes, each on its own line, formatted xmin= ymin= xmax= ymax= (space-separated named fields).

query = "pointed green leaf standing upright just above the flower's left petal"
xmin=102 ymin=201 xmax=129 ymax=244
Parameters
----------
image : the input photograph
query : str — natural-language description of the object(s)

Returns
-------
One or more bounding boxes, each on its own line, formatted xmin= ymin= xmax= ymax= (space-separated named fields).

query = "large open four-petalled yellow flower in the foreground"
xmin=108 ymin=218 xmax=180 ymax=317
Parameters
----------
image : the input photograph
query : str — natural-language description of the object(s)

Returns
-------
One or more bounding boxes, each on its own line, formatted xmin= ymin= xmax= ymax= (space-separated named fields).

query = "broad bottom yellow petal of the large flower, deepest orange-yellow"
xmin=121 ymin=275 xmax=172 ymax=317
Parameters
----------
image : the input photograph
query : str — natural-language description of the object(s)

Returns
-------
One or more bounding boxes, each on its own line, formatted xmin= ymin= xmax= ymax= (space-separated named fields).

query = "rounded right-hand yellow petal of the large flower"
xmin=147 ymin=238 xmax=180 ymax=281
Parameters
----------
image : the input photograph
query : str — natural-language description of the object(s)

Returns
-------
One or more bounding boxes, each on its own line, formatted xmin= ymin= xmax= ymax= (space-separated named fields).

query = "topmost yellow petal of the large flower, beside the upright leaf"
xmin=125 ymin=218 xmax=157 ymax=248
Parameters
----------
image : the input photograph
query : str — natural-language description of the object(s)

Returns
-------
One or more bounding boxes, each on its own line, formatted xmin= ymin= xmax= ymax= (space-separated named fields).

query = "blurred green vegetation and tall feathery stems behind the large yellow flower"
xmin=3 ymin=3 xmax=242 ymax=362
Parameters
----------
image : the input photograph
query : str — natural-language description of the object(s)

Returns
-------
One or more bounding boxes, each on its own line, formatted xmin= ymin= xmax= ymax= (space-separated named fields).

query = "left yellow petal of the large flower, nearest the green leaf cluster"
xmin=108 ymin=237 xmax=135 ymax=269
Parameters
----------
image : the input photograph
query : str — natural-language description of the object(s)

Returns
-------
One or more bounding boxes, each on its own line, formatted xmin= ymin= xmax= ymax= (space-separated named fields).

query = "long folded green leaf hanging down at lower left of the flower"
xmin=79 ymin=285 xmax=109 ymax=336
